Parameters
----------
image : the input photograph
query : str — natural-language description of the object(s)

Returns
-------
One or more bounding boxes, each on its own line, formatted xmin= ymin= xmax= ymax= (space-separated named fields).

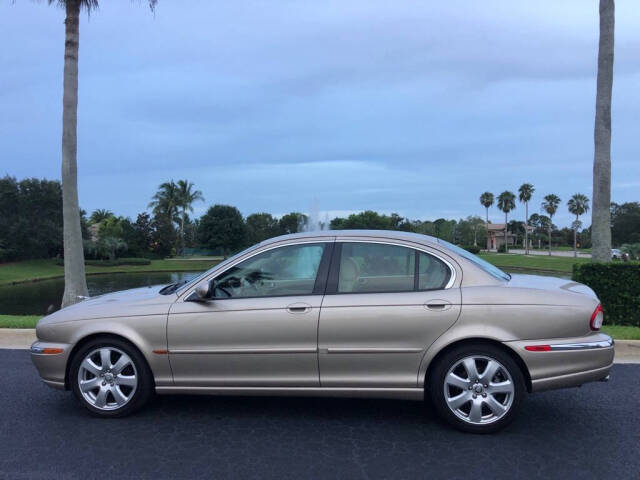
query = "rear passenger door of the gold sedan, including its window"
xmin=318 ymin=240 xmax=461 ymax=388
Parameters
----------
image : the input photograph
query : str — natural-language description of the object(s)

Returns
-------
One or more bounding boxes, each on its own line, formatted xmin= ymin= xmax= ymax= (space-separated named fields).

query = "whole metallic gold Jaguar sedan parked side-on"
xmin=31 ymin=230 xmax=614 ymax=433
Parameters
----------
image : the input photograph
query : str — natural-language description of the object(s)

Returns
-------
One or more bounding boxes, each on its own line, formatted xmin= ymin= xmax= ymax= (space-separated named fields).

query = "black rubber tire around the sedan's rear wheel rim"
xmin=427 ymin=343 xmax=526 ymax=433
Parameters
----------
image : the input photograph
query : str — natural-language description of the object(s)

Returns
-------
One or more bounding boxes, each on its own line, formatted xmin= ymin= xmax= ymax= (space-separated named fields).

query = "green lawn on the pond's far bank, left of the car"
xmin=0 ymin=257 xmax=221 ymax=285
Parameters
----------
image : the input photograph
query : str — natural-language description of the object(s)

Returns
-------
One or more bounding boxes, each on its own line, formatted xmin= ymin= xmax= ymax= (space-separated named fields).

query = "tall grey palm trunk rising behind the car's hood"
xmin=62 ymin=0 xmax=88 ymax=307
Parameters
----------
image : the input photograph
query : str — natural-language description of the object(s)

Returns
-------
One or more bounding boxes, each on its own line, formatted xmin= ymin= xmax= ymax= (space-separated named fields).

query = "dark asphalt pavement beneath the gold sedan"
xmin=0 ymin=350 xmax=640 ymax=480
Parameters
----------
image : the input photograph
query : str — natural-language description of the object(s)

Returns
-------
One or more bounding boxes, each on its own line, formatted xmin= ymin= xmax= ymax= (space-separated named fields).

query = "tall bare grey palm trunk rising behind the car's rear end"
xmin=591 ymin=0 xmax=615 ymax=262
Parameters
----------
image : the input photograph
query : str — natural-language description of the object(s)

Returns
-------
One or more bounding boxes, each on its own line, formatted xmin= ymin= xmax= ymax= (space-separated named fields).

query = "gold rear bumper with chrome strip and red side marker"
xmin=505 ymin=333 xmax=614 ymax=392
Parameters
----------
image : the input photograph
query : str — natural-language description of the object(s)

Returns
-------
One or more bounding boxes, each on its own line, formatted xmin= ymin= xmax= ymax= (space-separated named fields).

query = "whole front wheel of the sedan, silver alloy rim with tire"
xmin=69 ymin=338 xmax=153 ymax=417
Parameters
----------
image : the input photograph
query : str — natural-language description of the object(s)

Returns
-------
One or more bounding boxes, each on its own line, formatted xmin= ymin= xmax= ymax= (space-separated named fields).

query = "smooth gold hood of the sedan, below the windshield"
xmin=38 ymin=285 xmax=177 ymax=326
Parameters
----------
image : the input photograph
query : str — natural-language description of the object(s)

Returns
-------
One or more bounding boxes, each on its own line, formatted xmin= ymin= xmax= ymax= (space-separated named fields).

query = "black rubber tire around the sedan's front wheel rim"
xmin=69 ymin=337 xmax=155 ymax=418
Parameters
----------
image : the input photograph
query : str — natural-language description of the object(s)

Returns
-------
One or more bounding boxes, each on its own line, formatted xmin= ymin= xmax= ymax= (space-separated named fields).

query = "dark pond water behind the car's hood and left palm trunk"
xmin=0 ymin=272 xmax=200 ymax=315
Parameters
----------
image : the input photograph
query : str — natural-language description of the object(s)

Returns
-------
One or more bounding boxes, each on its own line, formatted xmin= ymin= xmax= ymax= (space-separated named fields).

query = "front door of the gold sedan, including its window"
xmin=167 ymin=242 xmax=333 ymax=387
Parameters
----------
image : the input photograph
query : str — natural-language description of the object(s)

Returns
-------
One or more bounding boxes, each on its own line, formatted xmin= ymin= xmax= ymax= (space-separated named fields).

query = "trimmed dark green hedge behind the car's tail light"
xmin=572 ymin=262 xmax=640 ymax=327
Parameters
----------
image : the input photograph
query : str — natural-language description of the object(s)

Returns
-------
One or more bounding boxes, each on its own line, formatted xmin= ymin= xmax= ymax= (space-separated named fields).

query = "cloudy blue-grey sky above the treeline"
xmin=0 ymin=0 xmax=640 ymax=226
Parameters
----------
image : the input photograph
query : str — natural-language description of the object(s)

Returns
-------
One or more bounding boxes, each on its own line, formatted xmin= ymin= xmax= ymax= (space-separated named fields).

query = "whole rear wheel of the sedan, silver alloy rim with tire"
xmin=429 ymin=344 xmax=525 ymax=433
